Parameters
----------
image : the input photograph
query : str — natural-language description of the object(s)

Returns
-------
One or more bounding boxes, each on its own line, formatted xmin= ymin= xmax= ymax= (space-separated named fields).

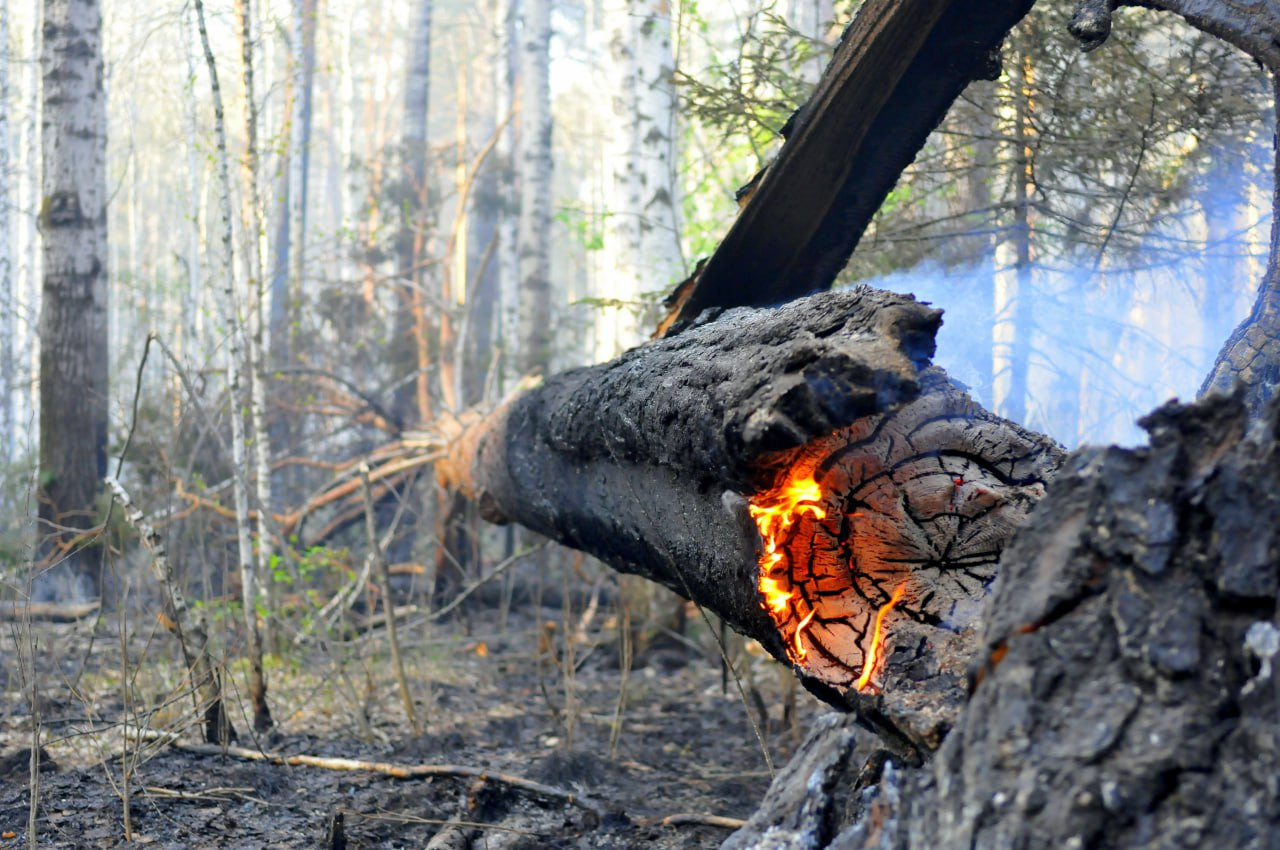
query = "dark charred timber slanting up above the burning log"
xmin=659 ymin=0 xmax=1032 ymax=333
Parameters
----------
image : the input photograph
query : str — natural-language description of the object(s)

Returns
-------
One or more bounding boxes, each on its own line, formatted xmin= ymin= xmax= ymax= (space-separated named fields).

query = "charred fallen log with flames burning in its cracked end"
xmin=439 ymin=288 xmax=1060 ymax=745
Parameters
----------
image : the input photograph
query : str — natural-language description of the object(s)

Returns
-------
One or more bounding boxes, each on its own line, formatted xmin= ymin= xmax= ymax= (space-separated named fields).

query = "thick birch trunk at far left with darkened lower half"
xmin=40 ymin=0 xmax=109 ymax=598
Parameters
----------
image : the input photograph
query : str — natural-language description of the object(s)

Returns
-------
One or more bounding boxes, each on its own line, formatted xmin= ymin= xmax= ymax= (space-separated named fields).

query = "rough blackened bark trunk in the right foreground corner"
xmin=726 ymin=397 xmax=1280 ymax=850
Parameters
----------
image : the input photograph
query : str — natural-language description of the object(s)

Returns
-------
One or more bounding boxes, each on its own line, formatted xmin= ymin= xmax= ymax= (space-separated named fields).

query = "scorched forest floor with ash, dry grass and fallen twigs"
xmin=0 ymin=583 xmax=820 ymax=850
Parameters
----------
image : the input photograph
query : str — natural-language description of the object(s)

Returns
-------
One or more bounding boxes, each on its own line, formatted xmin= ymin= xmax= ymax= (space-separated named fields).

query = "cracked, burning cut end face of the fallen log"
xmin=750 ymin=380 xmax=1047 ymax=690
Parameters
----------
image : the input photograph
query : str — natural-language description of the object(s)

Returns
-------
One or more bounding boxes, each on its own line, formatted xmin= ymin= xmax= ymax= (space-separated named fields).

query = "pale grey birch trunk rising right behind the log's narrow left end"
xmin=517 ymin=0 xmax=554 ymax=374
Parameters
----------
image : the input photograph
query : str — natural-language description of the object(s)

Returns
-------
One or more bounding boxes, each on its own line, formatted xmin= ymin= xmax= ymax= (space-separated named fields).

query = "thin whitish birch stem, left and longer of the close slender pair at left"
xmin=195 ymin=0 xmax=273 ymax=731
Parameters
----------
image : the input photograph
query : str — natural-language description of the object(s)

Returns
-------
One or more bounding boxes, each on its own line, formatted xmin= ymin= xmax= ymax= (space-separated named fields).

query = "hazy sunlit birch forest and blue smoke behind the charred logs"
xmin=0 ymin=0 xmax=1274 ymax=788
